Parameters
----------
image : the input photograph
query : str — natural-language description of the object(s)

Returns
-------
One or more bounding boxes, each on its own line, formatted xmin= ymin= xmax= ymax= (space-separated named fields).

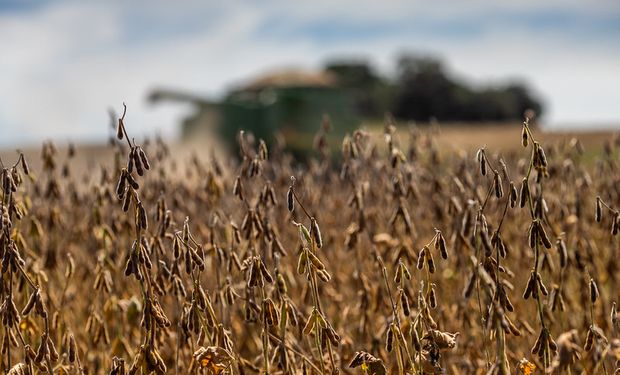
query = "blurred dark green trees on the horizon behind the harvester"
xmin=325 ymin=55 xmax=544 ymax=122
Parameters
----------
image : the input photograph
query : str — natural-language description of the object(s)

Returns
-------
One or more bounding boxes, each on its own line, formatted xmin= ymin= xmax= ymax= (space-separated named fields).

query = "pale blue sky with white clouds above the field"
xmin=0 ymin=0 xmax=620 ymax=146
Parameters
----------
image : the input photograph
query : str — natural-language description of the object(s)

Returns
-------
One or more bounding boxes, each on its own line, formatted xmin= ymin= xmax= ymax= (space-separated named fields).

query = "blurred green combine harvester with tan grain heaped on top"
xmin=150 ymin=71 xmax=359 ymax=156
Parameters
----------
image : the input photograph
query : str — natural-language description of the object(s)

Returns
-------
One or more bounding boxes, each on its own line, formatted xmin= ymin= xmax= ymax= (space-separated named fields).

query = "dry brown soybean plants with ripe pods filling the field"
xmin=0 ymin=107 xmax=620 ymax=375
